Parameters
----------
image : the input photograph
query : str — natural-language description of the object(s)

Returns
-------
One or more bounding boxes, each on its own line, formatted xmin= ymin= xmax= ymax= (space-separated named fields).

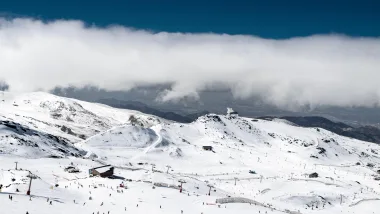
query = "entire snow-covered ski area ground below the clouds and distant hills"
xmin=0 ymin=93 xmax=380 ymax=214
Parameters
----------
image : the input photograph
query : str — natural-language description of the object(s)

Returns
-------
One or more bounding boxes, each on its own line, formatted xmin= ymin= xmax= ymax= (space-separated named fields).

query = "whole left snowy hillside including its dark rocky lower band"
xmin=0 ymin=92 xmax=160 ymax=157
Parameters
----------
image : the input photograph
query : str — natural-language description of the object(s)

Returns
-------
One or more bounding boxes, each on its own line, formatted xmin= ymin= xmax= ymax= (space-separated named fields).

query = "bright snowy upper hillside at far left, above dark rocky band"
xmin=0 ymin=92 xmax=159 ymax=142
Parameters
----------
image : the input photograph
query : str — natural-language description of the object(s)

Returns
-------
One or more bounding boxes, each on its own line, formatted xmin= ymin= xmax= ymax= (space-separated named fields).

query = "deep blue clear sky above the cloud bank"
xmin=0 ymin=0 xmax=380 ymax=38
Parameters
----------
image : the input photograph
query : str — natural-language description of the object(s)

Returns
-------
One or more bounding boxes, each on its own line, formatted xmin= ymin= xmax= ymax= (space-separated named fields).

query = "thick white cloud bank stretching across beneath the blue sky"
xmin=0 ymin=19 xmax=380 ymax=108
